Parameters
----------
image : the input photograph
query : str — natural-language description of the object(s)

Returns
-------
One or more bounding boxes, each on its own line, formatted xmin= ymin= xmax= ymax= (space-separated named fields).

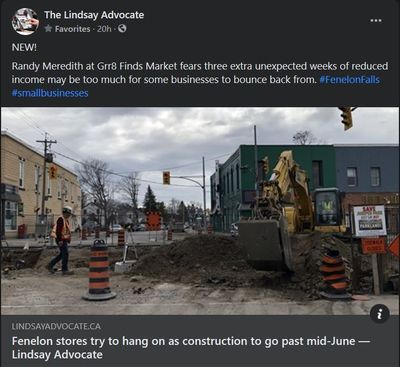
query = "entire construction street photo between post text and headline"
xmin=1 ymin=107 xmax=399 ymax=315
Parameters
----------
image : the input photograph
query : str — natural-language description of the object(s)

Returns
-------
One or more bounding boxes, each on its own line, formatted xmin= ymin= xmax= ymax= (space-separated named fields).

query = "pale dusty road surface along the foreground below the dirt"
xmin=1 ymin=268 xmax=399 ymax=315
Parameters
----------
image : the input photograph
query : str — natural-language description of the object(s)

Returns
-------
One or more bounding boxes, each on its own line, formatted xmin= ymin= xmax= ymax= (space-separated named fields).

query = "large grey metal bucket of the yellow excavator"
xmin=238 ymin=217 xmax=293 ymax=271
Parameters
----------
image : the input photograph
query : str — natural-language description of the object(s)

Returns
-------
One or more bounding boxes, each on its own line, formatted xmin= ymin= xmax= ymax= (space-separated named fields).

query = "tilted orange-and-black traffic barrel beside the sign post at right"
xmin=319 ymin=250 xmax=350 ymax=298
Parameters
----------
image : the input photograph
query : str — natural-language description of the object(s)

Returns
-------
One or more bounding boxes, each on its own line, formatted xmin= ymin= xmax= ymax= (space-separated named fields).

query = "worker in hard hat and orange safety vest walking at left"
xmin=46 ymin=206 xmax=74 ymax=275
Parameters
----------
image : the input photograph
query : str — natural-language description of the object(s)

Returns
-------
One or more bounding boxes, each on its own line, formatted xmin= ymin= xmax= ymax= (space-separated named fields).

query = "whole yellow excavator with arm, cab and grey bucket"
xmin=238 ymin=150 xmax=346 ymax=271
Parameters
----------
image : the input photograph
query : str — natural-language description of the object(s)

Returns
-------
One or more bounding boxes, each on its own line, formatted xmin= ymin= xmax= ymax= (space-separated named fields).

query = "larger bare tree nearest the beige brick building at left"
xmin=78 ymin=159 xmax=113 ymax=227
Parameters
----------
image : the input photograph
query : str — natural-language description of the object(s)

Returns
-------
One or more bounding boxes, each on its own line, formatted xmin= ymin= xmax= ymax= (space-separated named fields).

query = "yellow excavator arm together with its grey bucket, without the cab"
xmin=238 ymin=150 xmax=312 ymax=270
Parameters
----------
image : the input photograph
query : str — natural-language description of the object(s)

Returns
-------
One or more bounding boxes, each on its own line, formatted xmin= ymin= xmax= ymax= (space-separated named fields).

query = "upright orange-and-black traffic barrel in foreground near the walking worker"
xmin=83 ymin=240 xmax=116 ymax=301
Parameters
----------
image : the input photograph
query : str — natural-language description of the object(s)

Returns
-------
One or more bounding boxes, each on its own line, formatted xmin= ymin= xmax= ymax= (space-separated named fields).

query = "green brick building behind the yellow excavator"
xmin=211 ymin=145 xmax=336 ymax=231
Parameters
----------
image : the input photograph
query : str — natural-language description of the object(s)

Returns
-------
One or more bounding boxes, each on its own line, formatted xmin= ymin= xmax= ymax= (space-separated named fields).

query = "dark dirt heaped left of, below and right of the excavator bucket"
xmin=132 ymin=233 xmax=362 ymax=299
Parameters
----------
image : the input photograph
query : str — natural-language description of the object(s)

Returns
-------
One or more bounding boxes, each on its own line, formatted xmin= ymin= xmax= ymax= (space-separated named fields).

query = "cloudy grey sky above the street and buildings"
xmin=1 ymin=107 xmax=399 ymax=206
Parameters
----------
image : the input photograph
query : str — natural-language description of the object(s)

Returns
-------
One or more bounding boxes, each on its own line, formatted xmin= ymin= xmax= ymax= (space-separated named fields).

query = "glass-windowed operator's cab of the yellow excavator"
xmin=314 ymin=188 xmax=346 ymax=233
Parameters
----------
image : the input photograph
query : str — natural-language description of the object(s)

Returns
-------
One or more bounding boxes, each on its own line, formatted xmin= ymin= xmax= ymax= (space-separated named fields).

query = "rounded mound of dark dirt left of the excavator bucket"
xmin=133 ymin=235 xmax=260 ymax=287
